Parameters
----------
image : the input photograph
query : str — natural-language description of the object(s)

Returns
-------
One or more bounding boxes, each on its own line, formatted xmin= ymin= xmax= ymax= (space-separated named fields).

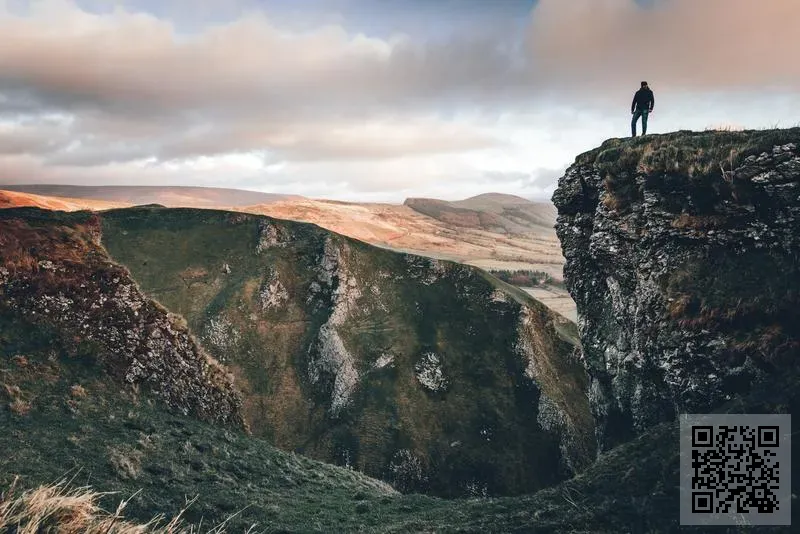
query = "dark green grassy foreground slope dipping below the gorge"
xmin=0 ymin=313 xmax=800 ymax=534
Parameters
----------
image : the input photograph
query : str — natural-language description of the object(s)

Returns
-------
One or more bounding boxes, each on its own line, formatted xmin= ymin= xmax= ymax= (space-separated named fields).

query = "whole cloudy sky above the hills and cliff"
xmin=0 ymin=0 xmax=800 ymax=202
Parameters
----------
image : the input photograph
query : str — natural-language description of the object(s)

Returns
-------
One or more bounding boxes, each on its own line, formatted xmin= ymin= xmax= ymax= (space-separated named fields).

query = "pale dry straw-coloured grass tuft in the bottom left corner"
xmin=0 ymin=480 xmax=242 ymax=534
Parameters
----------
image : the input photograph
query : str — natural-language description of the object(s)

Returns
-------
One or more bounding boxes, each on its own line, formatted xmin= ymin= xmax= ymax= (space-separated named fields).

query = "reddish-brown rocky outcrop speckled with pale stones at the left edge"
xmin=0 ymin=213 xmax=244 ymax=426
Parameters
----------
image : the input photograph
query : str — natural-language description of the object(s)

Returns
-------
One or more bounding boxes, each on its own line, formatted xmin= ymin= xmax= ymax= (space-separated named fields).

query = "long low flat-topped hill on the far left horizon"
xmin=0 ymin=184 xmax=298 ymax=208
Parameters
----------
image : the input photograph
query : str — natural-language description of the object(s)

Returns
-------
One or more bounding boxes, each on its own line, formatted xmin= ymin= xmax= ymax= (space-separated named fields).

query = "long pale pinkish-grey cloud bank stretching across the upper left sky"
xmin=0 ymin=0 xmax=522 ymax=118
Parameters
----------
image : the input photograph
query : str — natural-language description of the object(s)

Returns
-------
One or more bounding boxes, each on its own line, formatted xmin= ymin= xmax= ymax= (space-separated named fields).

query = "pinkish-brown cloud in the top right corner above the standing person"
xmin=527 ymin=0 xmax=800 ymax=93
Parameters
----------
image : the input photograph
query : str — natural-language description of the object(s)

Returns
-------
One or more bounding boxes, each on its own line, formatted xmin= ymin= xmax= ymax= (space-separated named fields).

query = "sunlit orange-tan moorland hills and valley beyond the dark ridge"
xmin=0 ymin=191 xmax=575 ymax=318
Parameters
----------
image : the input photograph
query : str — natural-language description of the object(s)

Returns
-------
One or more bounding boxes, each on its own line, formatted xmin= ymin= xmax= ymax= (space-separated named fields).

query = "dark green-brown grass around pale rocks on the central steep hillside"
xmin=92 ymin=208 xmax=588 ymax=496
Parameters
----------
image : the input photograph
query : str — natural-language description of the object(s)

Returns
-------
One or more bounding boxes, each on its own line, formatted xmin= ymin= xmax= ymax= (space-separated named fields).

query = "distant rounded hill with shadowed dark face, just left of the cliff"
xmin=404 ymin=193 xmax=556 ymax=235
